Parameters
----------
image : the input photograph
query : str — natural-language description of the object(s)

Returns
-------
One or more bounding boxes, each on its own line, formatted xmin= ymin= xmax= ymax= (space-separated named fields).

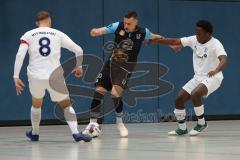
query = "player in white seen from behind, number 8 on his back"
xmin=13 ymin=11 xmax=91 ymax=141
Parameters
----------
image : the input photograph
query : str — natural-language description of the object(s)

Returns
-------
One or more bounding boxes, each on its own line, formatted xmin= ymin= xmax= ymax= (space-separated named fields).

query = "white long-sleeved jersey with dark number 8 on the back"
xmin=14 ymin=27 xmax=82 ymax=79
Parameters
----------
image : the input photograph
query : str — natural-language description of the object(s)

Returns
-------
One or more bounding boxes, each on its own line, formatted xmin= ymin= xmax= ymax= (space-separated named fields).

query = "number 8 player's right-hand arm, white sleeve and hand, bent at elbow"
xmin=61 ymin=33 xmax=83 ymax=77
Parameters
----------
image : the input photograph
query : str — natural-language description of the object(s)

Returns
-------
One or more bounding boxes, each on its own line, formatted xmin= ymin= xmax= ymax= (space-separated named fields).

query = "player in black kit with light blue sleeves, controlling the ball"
xmin=83 ymin=11 xmax=165 ymax=137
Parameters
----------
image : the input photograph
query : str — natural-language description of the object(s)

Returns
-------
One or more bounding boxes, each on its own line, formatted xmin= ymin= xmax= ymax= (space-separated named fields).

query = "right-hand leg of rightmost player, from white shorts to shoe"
xmin=189 ymin=77 xmax=222 ymax=136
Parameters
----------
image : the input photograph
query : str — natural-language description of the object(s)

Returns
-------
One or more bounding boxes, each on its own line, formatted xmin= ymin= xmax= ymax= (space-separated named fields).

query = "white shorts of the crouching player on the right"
xmin=182 ymin=76 xmax=222 ymax=97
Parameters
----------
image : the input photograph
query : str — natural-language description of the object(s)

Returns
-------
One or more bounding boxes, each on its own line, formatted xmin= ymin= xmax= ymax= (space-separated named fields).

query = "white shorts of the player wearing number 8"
xmin=28 ymin=78 xmax=69 ymax=102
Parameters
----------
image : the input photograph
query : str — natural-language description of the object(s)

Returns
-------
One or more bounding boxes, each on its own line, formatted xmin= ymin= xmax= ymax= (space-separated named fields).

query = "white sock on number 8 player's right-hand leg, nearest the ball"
xmin=64 ymin=106 xmax=79 ymax=134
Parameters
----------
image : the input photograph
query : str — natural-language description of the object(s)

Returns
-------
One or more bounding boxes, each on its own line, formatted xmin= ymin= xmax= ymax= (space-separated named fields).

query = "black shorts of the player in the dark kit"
xmin=95 ymin=60 xmax=131 ymax=91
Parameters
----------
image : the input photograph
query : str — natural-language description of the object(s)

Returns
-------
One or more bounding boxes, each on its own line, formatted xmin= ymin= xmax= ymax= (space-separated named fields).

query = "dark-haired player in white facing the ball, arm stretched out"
xmin=147 ymin=20 xmax=227 ymax=136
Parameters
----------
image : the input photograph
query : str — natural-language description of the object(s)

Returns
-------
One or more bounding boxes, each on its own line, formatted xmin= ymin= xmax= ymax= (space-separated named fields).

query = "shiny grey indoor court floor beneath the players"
xmin=0 ymin=121 xmax=240 ymax=160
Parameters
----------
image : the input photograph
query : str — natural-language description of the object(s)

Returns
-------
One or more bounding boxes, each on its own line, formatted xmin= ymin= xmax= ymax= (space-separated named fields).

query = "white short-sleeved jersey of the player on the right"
xmin=181 ymin=36 xmax=227 ymax=79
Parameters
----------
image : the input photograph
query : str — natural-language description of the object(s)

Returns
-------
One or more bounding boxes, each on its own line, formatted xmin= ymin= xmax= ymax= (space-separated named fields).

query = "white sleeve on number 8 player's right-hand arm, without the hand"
xmin=61 ymin=33 xmax=83 ymax=66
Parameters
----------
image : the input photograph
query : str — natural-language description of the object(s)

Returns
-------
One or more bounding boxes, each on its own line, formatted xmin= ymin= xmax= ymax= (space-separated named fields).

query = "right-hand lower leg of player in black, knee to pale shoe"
xmin=111 ymin=85 xmax=128 ymax=137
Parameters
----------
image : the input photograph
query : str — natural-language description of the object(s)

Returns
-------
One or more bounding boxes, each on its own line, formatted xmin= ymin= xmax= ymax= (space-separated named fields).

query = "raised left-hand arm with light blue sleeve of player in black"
xmin=90 ymin=22 xmax=119 ymax=37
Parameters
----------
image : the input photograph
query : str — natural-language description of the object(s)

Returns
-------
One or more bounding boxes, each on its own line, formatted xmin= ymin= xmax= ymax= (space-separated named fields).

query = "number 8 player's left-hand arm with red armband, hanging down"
xmin=13 ymin=39 xmax=29 ymax=95
